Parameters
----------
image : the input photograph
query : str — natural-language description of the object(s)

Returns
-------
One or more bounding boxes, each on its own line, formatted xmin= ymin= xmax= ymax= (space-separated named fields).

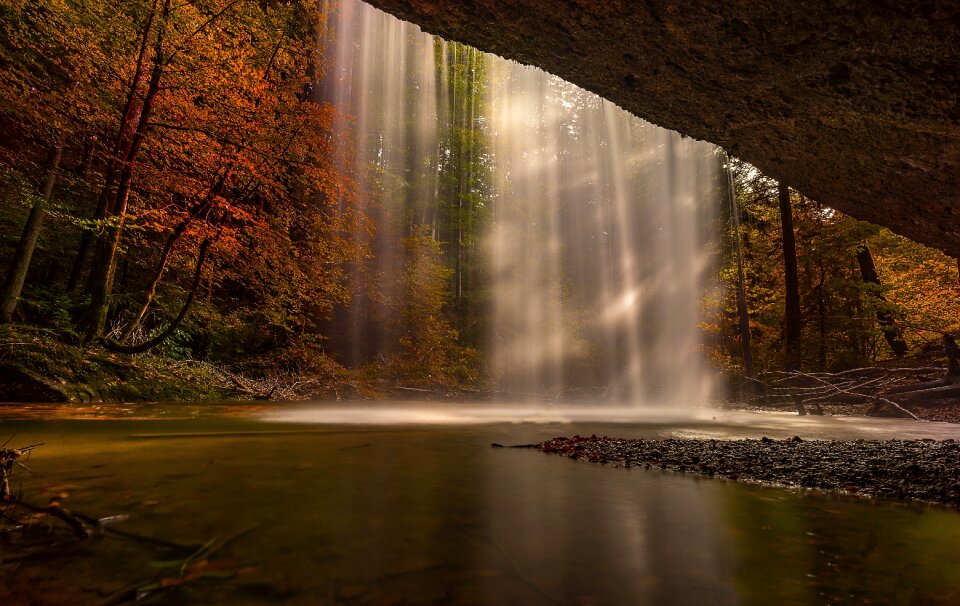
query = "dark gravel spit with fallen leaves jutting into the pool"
xmin=537 ymin=436 xmax=960 ymax=509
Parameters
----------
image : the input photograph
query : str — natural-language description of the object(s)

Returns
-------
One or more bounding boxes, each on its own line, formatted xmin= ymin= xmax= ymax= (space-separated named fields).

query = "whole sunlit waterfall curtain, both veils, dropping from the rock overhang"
xmin=326 ymin=0 xmax=719 ymax=404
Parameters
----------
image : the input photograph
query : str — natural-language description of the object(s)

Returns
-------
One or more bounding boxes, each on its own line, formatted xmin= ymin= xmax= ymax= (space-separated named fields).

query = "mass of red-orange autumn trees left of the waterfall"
xmin=0 ymin=0 xmax=369 ymax=364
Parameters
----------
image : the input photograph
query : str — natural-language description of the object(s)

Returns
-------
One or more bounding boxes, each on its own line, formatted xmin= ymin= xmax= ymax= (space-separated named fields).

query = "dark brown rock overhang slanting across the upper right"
xmin=368 ymin=0 xmax=960 ymax=256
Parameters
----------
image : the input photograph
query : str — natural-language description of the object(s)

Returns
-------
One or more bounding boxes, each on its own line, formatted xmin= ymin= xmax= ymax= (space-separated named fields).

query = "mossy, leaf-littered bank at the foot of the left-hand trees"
xmin=0 ymin=326 xmax=482 ymax=403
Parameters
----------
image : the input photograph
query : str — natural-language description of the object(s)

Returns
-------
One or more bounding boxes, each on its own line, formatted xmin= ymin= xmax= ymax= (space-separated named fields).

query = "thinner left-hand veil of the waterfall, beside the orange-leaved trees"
xmin=318 ymin=0 xmax=445 ymax=364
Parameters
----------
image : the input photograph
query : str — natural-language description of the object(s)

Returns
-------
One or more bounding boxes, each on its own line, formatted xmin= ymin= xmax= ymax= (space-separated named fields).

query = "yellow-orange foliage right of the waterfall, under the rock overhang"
xmin=707 ymin=161 xmax=960 ymax=371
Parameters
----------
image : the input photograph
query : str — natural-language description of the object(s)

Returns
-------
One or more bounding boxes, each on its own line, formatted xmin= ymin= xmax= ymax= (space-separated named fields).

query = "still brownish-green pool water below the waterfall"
xmin=0 ymin=405 xmax=960 ymax=605
